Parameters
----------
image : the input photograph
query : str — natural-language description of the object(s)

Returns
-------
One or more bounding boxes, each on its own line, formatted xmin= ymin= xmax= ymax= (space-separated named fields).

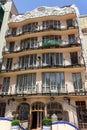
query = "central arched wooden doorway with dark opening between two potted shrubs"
xmin=31 ymin=102 xmax=44 ymax=129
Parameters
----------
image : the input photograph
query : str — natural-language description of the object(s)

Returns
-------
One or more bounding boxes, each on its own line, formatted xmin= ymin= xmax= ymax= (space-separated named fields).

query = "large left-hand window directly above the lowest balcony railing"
xmin=16 ymin=73 xmax=36 ymax=93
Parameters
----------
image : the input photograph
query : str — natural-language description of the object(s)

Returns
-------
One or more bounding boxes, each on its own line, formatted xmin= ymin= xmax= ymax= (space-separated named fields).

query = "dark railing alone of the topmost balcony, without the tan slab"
xmin=6 ymin=26 xmax=78 ymax=37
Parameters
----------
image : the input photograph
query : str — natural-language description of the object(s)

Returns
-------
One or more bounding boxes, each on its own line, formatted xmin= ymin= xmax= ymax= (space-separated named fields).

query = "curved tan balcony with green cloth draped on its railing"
xmin=3 ymin=40 xmax=81 ymax=57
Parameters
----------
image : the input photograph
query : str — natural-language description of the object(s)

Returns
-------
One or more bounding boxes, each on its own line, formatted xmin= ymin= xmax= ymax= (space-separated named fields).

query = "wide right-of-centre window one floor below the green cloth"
xmin=42 ymin=53 xmax=63 ymax=66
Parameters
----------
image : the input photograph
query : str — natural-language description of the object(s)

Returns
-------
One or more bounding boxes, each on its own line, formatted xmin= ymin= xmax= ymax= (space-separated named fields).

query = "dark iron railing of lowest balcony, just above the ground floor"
xmin=0 ymin=85 xmax=87 ymax=97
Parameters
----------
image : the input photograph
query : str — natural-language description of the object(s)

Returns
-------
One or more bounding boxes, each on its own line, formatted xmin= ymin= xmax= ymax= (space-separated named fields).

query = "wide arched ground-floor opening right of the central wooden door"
xmin=47 ymin=102 xmax=63 ymax=121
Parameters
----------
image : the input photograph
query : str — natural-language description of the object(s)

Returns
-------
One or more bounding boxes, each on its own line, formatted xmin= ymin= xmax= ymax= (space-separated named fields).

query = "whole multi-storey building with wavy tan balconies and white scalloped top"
xmin=0 ymin=5 xmax=87 ymax=130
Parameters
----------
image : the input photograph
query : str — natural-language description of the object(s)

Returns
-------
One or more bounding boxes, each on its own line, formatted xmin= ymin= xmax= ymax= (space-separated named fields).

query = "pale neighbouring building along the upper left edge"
xmin=0 ymin=0 xmax=18 ymax=63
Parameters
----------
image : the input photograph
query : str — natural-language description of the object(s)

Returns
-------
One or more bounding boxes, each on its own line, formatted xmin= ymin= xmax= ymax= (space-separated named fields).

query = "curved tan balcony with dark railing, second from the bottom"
xmin=0 ymin=64 xmax=85 ymax=76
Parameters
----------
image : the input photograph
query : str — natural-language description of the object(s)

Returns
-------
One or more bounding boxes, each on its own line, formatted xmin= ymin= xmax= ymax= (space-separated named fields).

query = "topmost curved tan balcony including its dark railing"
xmin=6 ymin=26 xmax=78 ymax=42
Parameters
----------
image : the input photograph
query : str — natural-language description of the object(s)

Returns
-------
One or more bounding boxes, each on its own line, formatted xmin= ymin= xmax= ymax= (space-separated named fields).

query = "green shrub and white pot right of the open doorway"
xmin=42 ymin=118 xmax=52 ymax=130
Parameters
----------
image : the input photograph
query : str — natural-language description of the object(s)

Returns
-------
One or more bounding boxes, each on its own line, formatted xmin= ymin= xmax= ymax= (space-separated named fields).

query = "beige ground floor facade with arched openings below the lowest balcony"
xmin=0 ymin=95 xmax=87 ymax=130
